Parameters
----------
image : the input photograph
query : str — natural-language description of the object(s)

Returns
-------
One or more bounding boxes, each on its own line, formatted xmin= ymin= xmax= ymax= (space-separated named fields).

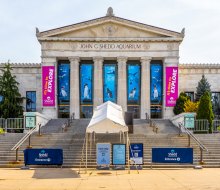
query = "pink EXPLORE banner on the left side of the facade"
xmin=42 ymin=66 xmax=55 ymax=106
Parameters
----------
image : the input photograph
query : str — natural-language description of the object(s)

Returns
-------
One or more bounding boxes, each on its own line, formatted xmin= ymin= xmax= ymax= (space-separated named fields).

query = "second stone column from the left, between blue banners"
xmin=93 ymin=57 xmax=103 ymax=108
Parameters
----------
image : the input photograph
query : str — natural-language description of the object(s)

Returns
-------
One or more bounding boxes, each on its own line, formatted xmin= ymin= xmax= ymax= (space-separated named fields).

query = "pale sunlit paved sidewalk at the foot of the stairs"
xmin=0 ymin=168 xmax=220 ymax=190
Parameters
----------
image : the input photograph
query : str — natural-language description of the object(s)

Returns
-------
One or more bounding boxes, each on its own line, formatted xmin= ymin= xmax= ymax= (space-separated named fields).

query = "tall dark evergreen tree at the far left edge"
xmin=0 ymin=62 xmax=24 ymax=118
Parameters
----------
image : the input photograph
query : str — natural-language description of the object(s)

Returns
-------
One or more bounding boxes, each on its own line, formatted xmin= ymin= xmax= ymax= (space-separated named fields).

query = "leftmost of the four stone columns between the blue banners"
xmin=69 ymin=57 xmax=80 ymax=119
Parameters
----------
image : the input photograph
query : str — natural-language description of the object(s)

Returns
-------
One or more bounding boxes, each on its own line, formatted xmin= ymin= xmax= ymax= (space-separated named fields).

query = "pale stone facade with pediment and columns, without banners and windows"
xmin=0 ymin=8 xmax=220 ymax=119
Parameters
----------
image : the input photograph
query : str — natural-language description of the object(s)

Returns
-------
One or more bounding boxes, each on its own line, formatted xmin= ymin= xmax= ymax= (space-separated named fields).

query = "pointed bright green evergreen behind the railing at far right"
xmin=196 ymin=91 xmax=214 ymax=133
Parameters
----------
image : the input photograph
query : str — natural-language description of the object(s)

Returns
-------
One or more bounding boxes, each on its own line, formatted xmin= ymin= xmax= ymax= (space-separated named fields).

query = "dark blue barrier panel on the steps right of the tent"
xmin=152 ymin=148 xmax=193 ymax=164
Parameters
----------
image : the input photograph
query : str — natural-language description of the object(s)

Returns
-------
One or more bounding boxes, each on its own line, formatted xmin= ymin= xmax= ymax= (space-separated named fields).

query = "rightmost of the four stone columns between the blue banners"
xmin=141 ymin=57 xmax=151 ymax=119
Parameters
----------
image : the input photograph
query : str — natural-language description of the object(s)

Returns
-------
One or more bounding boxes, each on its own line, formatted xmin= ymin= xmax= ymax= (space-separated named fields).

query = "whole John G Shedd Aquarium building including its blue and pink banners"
xmin=0 ymin=8 xmax=220 ymax=119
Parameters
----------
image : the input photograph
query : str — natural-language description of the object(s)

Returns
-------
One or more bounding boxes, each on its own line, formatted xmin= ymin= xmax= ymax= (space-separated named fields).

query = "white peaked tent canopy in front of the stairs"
xmin=86 ymin=101 xmax=128 ymax=133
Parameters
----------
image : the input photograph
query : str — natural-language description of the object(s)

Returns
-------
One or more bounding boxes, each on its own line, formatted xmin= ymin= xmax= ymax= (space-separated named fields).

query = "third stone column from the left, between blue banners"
xmin=117 ymin=57 xmax=127 ymax=111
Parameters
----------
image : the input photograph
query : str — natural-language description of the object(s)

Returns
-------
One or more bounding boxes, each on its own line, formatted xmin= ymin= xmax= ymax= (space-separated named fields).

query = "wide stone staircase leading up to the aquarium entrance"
xmin=0 ymin=119 xmax=220 ymax=168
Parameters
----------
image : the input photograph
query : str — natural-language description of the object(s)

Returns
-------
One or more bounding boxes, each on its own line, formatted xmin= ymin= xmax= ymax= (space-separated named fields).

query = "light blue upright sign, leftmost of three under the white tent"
xmin=96 ymin=143 xmax=111 ymax=166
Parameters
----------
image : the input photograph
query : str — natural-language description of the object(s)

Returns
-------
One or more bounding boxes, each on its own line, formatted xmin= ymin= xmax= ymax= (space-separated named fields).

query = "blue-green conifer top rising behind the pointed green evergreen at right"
xmin=196 ymin=74 xmax=211 ymax=101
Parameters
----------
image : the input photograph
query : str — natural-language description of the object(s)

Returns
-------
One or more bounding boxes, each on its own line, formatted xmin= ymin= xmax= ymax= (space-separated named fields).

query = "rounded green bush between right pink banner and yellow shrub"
xmin=173 ymin=92 xmax=189 ymax=115
